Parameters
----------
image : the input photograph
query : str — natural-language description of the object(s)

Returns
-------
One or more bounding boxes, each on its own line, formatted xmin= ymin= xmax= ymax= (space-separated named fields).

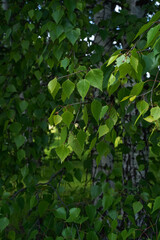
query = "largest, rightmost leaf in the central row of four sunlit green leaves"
xmin=85 ymin=69 xmax=103 ymax=91
